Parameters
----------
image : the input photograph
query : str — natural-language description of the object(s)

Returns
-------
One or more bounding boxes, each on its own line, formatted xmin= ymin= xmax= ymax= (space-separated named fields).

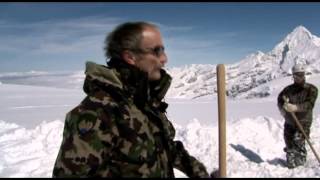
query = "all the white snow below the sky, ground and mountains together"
xmin=0 ymin=26 xmax=320 ymax=178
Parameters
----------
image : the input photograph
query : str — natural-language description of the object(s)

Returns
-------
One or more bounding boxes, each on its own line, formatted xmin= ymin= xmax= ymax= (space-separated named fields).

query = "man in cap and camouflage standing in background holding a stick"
xmin=278 ymin=64 xmax=318 ymax=168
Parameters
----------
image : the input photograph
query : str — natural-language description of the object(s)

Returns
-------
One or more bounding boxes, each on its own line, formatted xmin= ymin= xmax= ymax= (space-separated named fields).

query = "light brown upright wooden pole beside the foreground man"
xmin=217 ymin=64 xmax=227 ymax=177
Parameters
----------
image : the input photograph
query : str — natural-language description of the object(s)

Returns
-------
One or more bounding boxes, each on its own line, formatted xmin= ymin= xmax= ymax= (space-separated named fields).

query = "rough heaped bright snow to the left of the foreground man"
xmin=0 ymin=120 xmax=63 ymax=177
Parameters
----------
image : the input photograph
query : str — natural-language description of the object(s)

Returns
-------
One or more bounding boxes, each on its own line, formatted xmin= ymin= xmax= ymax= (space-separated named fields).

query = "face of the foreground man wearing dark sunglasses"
xmin=134 ymin=27 xmax=168 ymax=81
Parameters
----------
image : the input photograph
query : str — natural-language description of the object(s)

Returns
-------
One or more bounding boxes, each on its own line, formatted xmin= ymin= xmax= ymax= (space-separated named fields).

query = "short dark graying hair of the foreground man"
xmin=104 ymin=21 xmax=158 ymax=59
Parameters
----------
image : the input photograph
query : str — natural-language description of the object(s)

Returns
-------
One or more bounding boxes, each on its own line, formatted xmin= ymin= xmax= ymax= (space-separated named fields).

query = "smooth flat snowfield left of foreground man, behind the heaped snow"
xmin=0 ymin=84 xmax=84 ymax=128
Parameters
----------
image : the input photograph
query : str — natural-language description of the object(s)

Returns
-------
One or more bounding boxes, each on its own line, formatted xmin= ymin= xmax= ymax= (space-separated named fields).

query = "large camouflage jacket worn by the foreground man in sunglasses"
xmin=53 ymin=61 xmax=209 ymax=177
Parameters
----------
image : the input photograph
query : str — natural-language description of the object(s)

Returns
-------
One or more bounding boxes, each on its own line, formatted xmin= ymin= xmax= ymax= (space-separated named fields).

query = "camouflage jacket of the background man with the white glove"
xmin=278 ymin=83 xmax=318 ymax=126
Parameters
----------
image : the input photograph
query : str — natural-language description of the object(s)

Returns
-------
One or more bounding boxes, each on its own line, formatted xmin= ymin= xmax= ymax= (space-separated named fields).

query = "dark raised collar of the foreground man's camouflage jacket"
xmin=84 ymin=58 xmax=172 ymax=104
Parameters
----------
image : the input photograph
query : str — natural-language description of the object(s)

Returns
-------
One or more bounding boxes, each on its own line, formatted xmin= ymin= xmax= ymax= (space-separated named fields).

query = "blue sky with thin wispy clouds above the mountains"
xmin=0 ymin=2 xmax=320 ymax=72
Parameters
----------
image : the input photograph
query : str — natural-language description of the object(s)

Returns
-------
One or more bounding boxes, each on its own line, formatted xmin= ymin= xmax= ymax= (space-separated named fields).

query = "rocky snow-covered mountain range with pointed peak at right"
xmin=168 ymin=26 xmax=320 ymax=98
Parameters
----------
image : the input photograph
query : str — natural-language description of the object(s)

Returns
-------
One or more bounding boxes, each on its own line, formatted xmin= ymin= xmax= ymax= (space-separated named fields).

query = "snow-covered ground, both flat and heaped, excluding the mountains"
xmin=0 ymin=76 xmax=320 ymax=177
